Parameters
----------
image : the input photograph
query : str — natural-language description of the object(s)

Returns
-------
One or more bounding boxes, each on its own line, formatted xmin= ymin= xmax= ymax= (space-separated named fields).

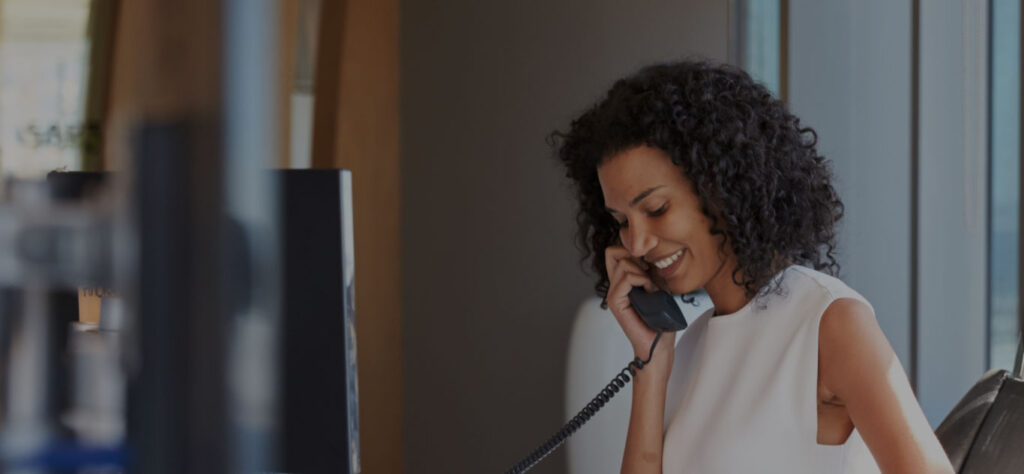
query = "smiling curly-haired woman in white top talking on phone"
xmin=554 ymin=61 xmax=952 ymax=473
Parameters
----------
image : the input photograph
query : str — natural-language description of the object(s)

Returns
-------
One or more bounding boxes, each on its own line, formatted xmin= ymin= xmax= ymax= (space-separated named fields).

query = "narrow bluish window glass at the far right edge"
xmin=988 ymin=1 xmax=1021 ymax=370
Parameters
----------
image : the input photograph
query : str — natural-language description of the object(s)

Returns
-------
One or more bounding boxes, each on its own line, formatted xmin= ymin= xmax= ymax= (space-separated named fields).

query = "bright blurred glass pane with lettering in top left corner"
xmin=0 ymin=0 xmax=90 ymax=178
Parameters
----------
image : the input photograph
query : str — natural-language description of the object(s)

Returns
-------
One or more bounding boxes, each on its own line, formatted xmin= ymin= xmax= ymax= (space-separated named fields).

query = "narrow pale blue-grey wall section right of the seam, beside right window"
xmin=915 ymin=0 xmax=988 ymax=426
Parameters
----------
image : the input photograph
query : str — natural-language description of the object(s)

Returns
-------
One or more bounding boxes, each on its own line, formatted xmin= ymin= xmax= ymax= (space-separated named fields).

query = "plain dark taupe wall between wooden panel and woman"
xmin=399 ymin=0 xmax=728 ymax=473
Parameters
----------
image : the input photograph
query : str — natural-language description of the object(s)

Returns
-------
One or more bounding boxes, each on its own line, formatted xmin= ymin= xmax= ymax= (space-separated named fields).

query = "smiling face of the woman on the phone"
xmin=597 ymin=146 xmax=735 ymax=294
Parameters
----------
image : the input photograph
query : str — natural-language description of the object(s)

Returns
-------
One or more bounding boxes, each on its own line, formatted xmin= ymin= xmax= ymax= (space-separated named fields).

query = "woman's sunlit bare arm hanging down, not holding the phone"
xmin=818 ymin=298 xmax=953 ymax=474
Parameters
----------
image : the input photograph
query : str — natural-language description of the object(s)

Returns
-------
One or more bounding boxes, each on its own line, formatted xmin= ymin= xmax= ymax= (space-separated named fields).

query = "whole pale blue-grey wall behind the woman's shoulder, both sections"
xmin=788 ymin=0 xmax=987 ymax=426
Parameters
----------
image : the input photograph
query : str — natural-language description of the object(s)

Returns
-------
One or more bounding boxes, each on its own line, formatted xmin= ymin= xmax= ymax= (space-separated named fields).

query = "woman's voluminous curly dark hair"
xmin=549 ymin=60 xmax=844 ymax=307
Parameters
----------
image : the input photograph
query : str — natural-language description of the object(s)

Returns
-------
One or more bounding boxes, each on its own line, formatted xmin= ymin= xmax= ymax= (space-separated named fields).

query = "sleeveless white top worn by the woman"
xmin=663 ymin=265 xmax=880 ymax=474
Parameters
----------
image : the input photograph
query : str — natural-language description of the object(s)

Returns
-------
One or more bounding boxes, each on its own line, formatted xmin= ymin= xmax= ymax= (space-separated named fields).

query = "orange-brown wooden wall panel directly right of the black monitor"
xmin=337 ymin=0 xmax=402 ymax=473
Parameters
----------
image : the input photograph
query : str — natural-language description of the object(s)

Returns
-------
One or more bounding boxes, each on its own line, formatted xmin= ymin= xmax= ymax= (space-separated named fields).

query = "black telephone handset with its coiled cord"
xmin=505 ymin=287 xmax=698 ymax=474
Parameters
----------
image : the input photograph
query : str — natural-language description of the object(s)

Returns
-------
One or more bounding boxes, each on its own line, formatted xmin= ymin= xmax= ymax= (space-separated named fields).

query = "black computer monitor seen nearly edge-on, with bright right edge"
xmin=276 ymin=170 xmax=360 ymax=472
